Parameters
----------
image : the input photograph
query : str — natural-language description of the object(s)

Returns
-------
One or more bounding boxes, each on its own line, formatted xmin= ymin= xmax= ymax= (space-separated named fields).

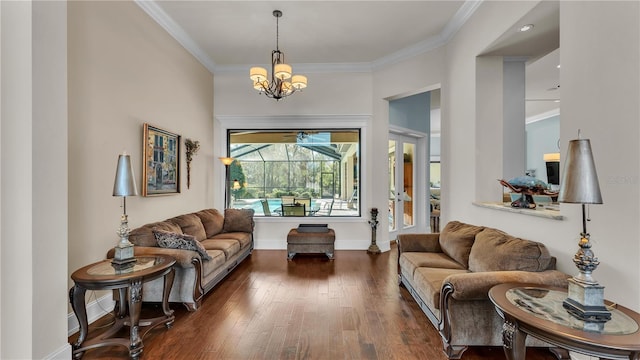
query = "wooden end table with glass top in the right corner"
xmin=489 ymin=284 xmax=640 ymax=360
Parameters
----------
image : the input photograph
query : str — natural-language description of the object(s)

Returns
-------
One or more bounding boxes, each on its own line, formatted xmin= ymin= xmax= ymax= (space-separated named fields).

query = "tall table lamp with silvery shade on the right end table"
xmin=558 ymin=136 xmax=611 ymax=322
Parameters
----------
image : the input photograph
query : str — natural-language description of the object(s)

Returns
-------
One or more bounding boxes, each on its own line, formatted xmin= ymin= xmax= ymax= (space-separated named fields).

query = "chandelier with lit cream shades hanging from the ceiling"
xmin=249 ymin=10 xmax=307 ymax=100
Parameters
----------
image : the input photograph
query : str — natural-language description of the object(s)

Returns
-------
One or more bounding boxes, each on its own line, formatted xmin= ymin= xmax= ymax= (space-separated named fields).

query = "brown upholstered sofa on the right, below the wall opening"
xmin=397 ymin=221 xmax=569 ymax=359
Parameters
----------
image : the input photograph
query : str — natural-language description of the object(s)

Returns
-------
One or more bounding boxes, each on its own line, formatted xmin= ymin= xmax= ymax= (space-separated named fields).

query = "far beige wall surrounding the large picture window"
xmin=214 ymin=70 xmax=376 ymax=249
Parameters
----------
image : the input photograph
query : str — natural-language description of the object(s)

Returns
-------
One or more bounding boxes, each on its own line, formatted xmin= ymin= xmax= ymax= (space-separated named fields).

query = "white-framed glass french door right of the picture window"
xmin=389 ymin=134 xmax=422 ymax=239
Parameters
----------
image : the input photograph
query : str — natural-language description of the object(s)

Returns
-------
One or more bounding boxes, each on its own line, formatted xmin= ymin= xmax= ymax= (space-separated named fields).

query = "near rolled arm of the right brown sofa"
xmin=440 ymin=270 xmax=569 ymax=300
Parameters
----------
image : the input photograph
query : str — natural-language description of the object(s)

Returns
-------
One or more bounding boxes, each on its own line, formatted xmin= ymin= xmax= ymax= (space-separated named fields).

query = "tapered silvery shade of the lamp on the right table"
xmin=558 ymin=139 xmax=602 ymax=204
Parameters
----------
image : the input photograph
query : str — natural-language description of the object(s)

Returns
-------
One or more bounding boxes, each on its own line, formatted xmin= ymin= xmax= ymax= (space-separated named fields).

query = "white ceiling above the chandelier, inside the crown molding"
xmin=138 ymin=0 xmax=479 ymax=71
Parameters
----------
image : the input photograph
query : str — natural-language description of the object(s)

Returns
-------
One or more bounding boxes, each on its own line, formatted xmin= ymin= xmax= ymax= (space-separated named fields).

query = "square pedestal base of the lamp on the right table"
xmin=562 ymin=278 xmax=611 ymax=323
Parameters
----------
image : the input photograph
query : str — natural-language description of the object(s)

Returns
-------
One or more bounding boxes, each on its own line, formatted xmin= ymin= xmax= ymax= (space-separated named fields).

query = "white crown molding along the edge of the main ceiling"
xmin=134 ymin=0 xmax=484 ymax=74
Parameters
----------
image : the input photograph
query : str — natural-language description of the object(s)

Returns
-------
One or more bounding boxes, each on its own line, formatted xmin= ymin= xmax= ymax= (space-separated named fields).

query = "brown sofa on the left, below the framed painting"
xmin=107 ymin=209 xmax=255 ymax=311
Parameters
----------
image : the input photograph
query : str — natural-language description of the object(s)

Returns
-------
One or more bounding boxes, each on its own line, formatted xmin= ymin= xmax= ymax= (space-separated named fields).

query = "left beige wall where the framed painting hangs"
xmin=68 ymin=1 xmax=214 ymax=294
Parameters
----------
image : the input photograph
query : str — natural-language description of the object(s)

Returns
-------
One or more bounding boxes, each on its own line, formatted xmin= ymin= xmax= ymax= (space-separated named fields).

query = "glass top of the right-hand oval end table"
xmin=506 ymin=287 xmax=638 ymax=335
